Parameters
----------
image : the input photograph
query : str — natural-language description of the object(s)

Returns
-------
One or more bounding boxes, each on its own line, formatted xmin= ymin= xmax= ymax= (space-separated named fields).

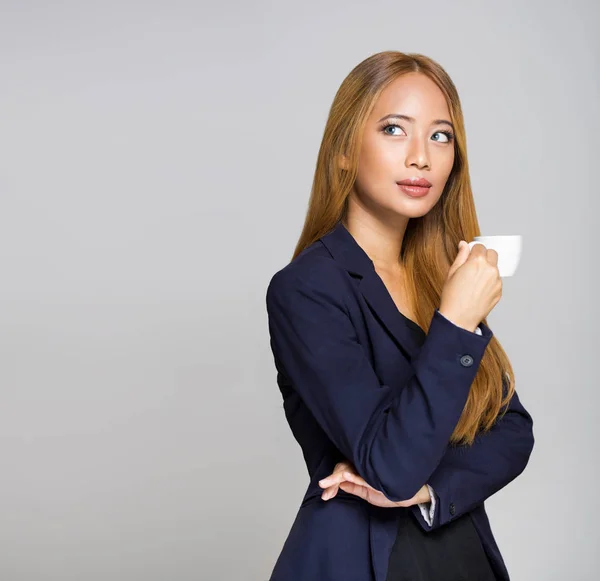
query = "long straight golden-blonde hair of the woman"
xmin=292 ymin=51 xmax=515 ymax=445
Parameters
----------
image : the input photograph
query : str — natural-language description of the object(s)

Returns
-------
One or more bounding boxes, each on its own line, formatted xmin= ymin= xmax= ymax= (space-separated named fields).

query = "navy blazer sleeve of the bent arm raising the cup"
xmin=266 ymin=260 xmax=493 ymax=502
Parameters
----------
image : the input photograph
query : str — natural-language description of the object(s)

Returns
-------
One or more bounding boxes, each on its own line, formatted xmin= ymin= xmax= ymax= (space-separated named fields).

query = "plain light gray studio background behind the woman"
xmin=0 ymin=0 xmax=600 ymax=581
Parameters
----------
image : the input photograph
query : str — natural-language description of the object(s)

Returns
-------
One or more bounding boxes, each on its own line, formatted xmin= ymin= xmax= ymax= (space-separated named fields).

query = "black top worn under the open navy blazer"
xmin=386 ymin=313 xmax=496 ymax=581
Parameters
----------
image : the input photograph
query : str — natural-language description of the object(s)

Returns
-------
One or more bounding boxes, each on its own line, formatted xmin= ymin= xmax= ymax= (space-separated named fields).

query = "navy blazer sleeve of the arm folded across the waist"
xmin=413 ymin=382 xmax=535 ymax=531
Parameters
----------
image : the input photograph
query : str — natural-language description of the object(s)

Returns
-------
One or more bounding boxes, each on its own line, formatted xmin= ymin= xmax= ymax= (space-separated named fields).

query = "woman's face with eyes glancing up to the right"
xmin=342 ymin=73 xmax=454 ymax=219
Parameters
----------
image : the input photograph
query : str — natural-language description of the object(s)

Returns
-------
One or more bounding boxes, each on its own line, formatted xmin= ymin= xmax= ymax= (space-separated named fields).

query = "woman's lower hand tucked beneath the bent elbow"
xmin=319 ymin=462 xmax=431 ymax=508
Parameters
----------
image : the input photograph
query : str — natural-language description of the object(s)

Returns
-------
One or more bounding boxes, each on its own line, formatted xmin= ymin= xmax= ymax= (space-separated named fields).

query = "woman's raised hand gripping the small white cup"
xmin=438 ymin=240 xmax=502 ymax=332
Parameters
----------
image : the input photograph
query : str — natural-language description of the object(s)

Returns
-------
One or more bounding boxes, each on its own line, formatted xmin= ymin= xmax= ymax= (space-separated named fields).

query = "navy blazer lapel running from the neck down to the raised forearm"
xmin=320 ymin=221 xmax=421 ymax=361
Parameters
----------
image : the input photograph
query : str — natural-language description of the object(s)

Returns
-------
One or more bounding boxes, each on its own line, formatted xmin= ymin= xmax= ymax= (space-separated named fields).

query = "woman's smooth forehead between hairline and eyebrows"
xmin=370 ymin=73 xmax=450 ymax=123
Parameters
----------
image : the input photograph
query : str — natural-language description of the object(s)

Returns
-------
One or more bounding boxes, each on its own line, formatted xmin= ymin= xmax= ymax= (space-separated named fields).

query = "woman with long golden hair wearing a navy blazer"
xmin=266 ymin=51 xmax=534 ymax=581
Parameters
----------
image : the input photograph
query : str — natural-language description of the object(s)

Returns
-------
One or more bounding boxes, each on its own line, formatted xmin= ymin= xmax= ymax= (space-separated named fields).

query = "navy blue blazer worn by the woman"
xmin=266 ymin=221 xmax=534 ymax=581
